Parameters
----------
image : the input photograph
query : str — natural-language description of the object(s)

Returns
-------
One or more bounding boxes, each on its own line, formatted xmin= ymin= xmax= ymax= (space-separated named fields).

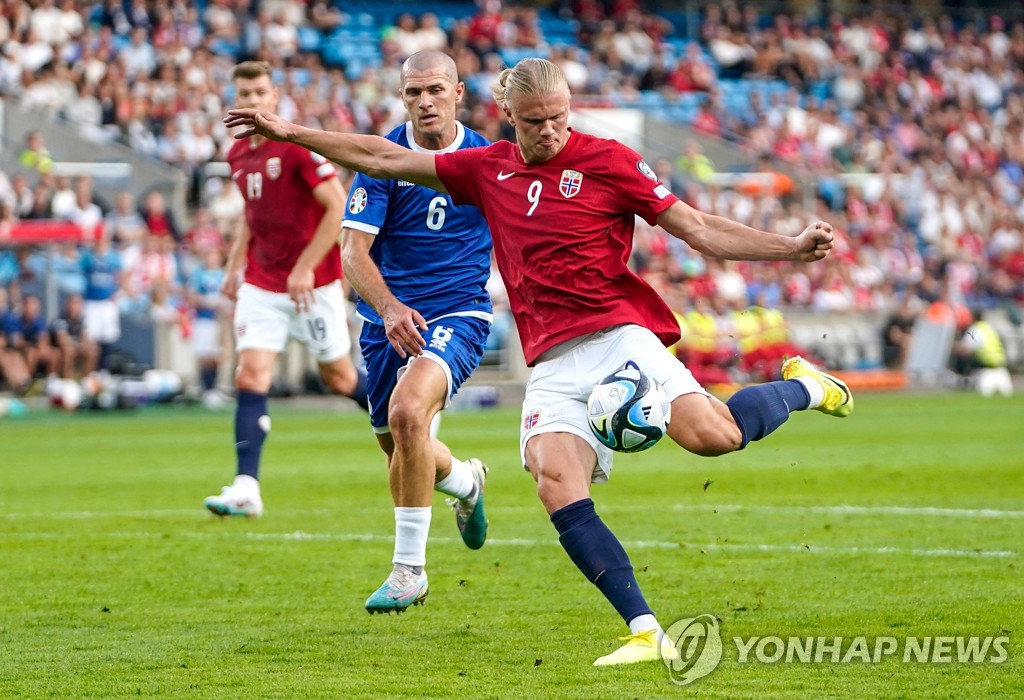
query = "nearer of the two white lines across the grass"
xmin=0 ymin=530 xmax=1017 ymax=558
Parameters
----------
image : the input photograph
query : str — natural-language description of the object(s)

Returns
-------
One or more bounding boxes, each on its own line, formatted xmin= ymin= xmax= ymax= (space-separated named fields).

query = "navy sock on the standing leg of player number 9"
xmin=551 ymin=498 xmax=653 ymax=624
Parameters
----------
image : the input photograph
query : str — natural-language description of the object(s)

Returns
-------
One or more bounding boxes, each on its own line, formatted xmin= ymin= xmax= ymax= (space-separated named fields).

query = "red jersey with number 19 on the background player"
xmin=227 ymin=139 xmax=341 ymax=292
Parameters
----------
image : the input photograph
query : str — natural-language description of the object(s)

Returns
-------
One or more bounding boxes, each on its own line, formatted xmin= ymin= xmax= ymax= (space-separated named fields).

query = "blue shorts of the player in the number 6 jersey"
xmin=359 ymin=316 xmax=490 ymax=433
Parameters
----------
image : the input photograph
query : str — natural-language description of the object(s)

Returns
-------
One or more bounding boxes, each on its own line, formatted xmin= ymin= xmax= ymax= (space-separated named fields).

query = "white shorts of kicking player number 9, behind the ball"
xmin=519 ymin=324 xmax=708 ymax=483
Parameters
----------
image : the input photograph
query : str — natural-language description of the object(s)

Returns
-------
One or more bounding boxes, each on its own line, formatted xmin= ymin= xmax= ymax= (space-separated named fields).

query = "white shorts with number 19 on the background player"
xmin=234 ymin=280 xmax=352 ymax=364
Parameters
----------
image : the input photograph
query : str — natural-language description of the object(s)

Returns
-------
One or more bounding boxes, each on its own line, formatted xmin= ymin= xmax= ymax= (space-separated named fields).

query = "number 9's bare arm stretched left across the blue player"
xmin=224 ymin=110 xmax=447 ymax=193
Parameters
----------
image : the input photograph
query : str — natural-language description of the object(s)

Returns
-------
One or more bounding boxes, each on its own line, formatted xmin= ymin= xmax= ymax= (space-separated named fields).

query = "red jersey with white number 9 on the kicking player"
xmin=435 ymin=131 xmax=679 ymax=365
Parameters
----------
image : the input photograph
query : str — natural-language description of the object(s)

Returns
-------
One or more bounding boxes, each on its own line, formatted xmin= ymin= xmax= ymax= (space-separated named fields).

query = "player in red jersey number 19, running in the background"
xmin=205 ymin=61 xmax=367 ymax=517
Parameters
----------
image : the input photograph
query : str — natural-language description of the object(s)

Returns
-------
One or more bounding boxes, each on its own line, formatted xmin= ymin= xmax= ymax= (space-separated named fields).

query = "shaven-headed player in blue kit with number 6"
xmin=342 ymin=51 xmax=492 ymax=613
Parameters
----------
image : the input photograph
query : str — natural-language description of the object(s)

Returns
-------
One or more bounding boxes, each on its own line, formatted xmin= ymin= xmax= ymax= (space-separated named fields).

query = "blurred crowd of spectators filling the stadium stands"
xmin=0 ymin=0 xmax=1024 ymax=387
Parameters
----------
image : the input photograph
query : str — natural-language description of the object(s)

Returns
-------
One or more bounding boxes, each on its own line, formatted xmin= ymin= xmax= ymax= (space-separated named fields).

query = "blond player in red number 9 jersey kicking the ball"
xmin=224 ymin=58 xmax=853 ymax=665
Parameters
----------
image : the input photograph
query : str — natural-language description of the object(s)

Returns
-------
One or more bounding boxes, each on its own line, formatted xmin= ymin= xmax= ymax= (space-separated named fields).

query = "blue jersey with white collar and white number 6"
xmin=343 ymin=122 xmax=492 ymax=324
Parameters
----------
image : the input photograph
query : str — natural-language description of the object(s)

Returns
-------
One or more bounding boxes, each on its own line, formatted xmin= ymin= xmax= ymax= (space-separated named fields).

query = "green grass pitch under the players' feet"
xmin=0 ymin=394 xmax=1024 ymax=698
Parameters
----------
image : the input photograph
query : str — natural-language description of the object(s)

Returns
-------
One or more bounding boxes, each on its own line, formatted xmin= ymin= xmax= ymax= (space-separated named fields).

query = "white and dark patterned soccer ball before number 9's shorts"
xmin=587 ymin=361 xmax=672 ymax=452
